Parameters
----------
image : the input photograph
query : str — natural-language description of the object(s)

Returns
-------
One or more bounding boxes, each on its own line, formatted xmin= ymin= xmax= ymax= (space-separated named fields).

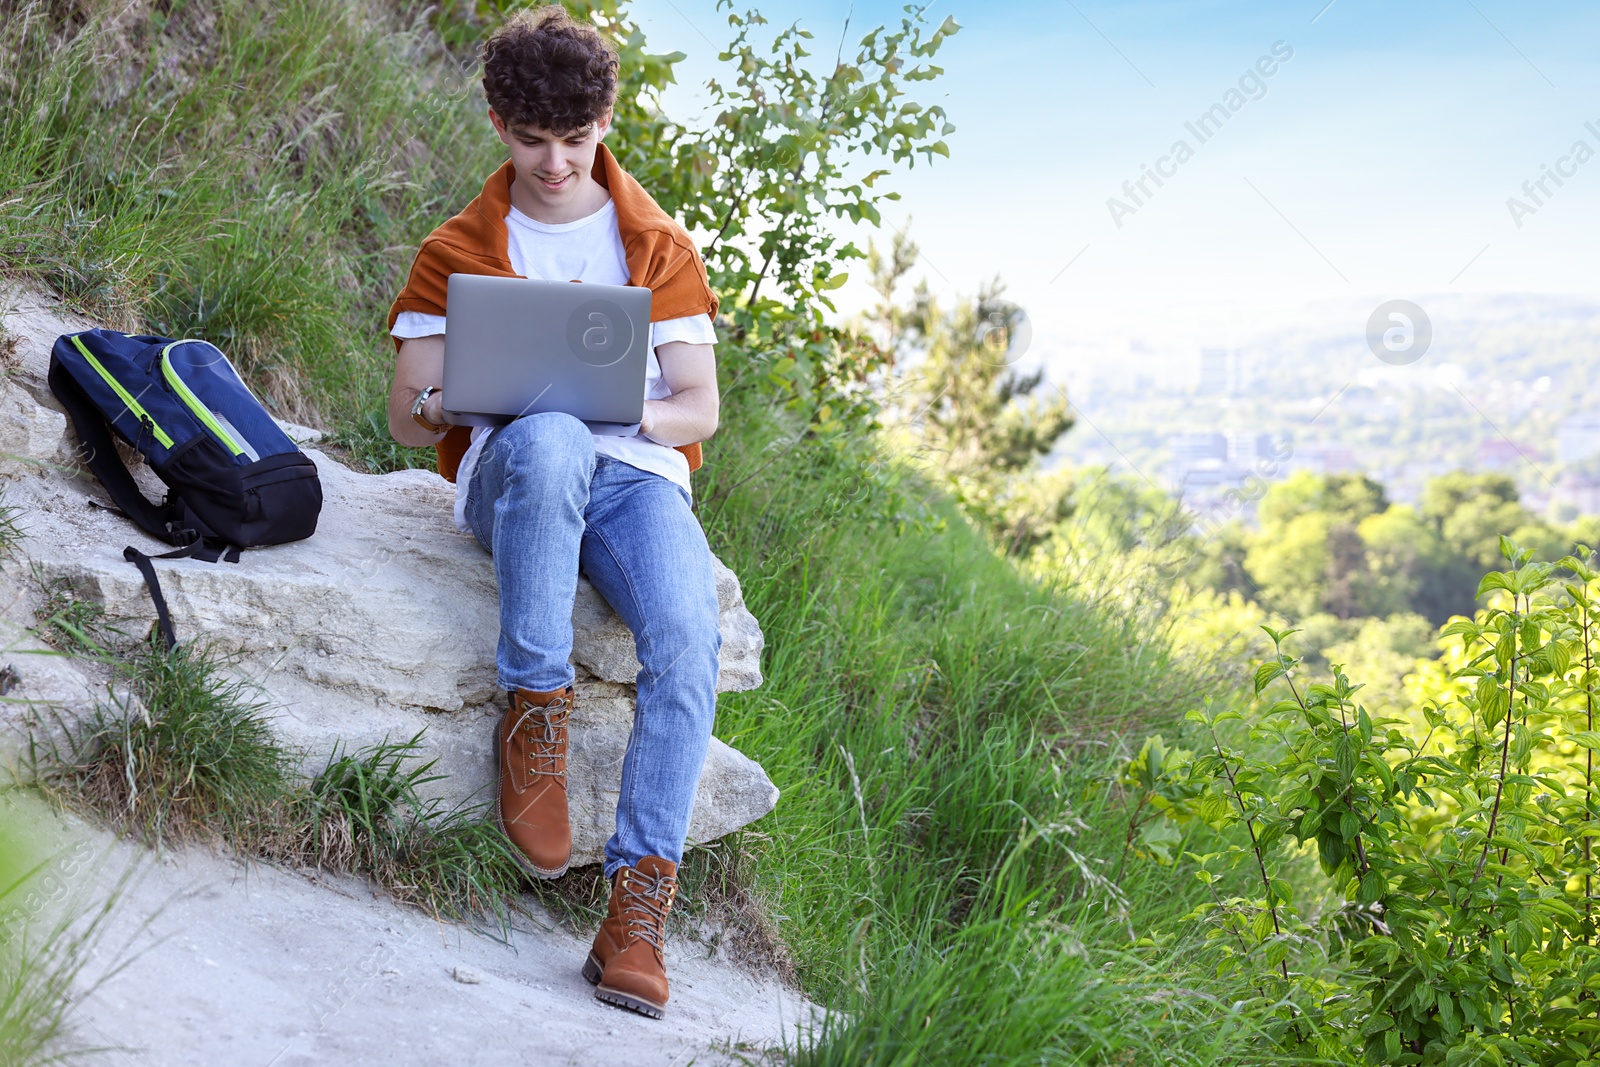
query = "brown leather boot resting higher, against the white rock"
xmin=494 ymin=686 xmax=576 ymax=878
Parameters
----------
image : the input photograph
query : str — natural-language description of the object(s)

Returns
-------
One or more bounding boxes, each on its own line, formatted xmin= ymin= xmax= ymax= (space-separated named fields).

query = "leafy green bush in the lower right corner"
xmin=1165 ymin=537 xmax=1600 ymax=1067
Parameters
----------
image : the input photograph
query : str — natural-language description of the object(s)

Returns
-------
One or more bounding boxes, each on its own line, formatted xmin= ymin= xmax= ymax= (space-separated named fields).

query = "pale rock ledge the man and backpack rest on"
xmin=0 ymin=288 xmax=778 ymax=864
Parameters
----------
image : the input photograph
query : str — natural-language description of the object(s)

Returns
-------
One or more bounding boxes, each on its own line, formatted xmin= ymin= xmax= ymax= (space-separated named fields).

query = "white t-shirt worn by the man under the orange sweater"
xmin=392 ymin=200 xmax=717 ymax=533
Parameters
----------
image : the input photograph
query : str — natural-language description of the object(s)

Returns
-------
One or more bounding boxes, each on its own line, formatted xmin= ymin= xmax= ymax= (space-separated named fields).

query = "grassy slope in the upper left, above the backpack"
xmin=0 ymin=0 xmax=502 ymax=427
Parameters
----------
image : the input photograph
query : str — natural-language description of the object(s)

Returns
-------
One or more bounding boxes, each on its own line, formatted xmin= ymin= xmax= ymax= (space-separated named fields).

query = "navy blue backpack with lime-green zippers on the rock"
xmin=50 ymin=330 xmax=322 ymax=645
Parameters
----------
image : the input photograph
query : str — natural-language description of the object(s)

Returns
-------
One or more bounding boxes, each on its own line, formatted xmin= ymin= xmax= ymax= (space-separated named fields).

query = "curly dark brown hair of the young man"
xmin=483 ymin=3 xmax=618 ymax=136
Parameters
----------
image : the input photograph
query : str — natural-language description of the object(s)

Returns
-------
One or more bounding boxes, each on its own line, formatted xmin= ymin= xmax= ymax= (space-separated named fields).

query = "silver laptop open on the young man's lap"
xmin=445 ymin=274 xmax=650 ymax=437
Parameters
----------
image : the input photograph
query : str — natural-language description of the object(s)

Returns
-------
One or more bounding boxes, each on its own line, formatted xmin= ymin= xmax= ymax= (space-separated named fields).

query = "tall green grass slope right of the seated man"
xmin=681 ymin=375 xmax=1282 ymax=1064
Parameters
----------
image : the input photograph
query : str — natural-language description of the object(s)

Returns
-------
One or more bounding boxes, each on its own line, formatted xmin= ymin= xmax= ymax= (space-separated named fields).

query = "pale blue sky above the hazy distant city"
xmin=632 ymin=0 xmax=1600 ymax=362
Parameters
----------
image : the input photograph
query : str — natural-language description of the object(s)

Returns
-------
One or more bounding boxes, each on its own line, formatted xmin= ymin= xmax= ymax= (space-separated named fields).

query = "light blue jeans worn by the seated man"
xmin=466 ymin=411 xmax=722 ymax=878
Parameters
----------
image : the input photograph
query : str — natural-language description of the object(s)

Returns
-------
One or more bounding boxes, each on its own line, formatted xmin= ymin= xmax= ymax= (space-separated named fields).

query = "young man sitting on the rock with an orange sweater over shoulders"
xmin=389 ymin=5 xmax=722 ymax=1017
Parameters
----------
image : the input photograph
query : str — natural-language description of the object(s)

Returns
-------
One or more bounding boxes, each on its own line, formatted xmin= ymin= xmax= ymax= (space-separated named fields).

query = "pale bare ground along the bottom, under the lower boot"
xmin=26 ymin=793 xmax=824 ymax=1067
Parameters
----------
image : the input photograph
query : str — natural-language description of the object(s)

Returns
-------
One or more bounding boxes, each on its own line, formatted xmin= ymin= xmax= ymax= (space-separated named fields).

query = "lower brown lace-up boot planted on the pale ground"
xmin=584 ymin=856 xmax=678 ymax=1019
